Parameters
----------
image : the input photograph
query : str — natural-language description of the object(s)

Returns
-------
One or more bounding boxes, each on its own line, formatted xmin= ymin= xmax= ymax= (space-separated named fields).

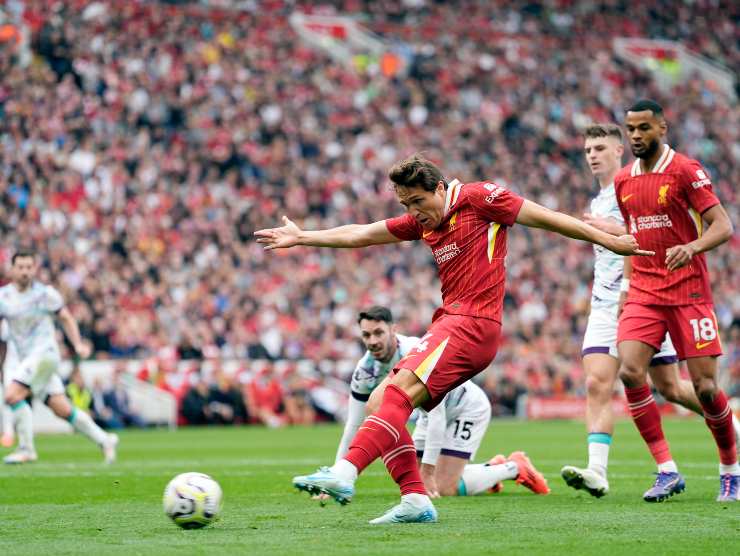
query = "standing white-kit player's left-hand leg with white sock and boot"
xmin=560 ymin=352 xmax=619 ymax=498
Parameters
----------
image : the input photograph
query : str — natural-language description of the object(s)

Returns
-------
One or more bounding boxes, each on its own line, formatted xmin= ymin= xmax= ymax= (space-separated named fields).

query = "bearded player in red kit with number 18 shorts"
xmin=614 ymin=100 xmax=740 ymax=502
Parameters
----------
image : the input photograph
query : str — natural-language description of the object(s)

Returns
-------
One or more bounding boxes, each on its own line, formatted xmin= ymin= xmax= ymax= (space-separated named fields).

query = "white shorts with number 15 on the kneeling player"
xmin=412 ymin=400 xmax=491 ymax=460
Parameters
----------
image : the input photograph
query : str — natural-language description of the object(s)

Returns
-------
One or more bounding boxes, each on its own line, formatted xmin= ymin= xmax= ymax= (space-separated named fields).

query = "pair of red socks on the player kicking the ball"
xmin=344 ymin=384 xmax=426 ymax=494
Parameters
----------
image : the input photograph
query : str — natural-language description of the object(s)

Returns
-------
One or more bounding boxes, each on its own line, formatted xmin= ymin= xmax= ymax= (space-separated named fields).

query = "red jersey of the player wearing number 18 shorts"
xmin=614 ymin=145 xmax=719 ymax=305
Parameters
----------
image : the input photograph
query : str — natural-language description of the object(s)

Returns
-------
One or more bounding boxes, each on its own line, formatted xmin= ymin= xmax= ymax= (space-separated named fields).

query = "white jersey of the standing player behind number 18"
xmin=591 ymin=183 xmax=624 ymax=307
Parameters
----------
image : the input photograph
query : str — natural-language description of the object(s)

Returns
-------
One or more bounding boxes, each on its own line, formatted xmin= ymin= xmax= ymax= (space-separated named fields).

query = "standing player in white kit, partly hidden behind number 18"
xmin=561 ymin=124 xmax=740 ymax=498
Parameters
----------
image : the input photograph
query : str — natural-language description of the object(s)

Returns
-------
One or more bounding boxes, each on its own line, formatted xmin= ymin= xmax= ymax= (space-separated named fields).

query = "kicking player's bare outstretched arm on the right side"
xmin=516 ymin=199 xmax=655 ymax=255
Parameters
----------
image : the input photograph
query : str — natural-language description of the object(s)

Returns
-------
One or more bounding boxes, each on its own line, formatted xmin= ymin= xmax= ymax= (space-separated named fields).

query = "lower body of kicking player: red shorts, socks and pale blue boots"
xmin=293 ymin=315 xmax=500 ymax=523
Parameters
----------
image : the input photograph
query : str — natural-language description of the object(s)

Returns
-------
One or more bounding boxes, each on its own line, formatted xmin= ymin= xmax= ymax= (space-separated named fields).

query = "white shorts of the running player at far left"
xmin=3 ymin=346 xmax=64 ymax=401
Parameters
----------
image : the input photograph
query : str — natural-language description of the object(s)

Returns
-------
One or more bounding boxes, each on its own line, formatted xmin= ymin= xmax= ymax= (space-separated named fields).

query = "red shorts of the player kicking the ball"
xmin=393 ymin=313 xmax=501 ymax=410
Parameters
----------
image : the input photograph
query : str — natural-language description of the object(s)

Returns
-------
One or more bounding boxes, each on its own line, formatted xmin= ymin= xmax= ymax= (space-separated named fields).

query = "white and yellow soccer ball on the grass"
xmin=163 ymin=473 xmax=222 ymax=529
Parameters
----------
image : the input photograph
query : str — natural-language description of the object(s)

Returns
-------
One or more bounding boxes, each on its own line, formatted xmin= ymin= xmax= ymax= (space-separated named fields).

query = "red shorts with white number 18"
xmin=617 ymin=303 xmax=722 ymax=360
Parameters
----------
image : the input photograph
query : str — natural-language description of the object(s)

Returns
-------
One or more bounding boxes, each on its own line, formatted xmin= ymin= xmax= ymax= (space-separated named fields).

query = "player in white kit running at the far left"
xmin=0 ymin=251 xmax=118 ymax=463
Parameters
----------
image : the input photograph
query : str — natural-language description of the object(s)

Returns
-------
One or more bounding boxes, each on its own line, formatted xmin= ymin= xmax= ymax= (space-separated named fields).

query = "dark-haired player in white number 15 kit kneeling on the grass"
xmin=336 ymin=306 xmax=549 ymax=497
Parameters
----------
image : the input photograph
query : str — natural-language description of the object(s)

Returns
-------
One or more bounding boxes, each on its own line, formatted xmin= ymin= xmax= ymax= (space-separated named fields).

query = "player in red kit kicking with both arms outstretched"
xmin=255 ymin=151 xmax=650 ymax=523
